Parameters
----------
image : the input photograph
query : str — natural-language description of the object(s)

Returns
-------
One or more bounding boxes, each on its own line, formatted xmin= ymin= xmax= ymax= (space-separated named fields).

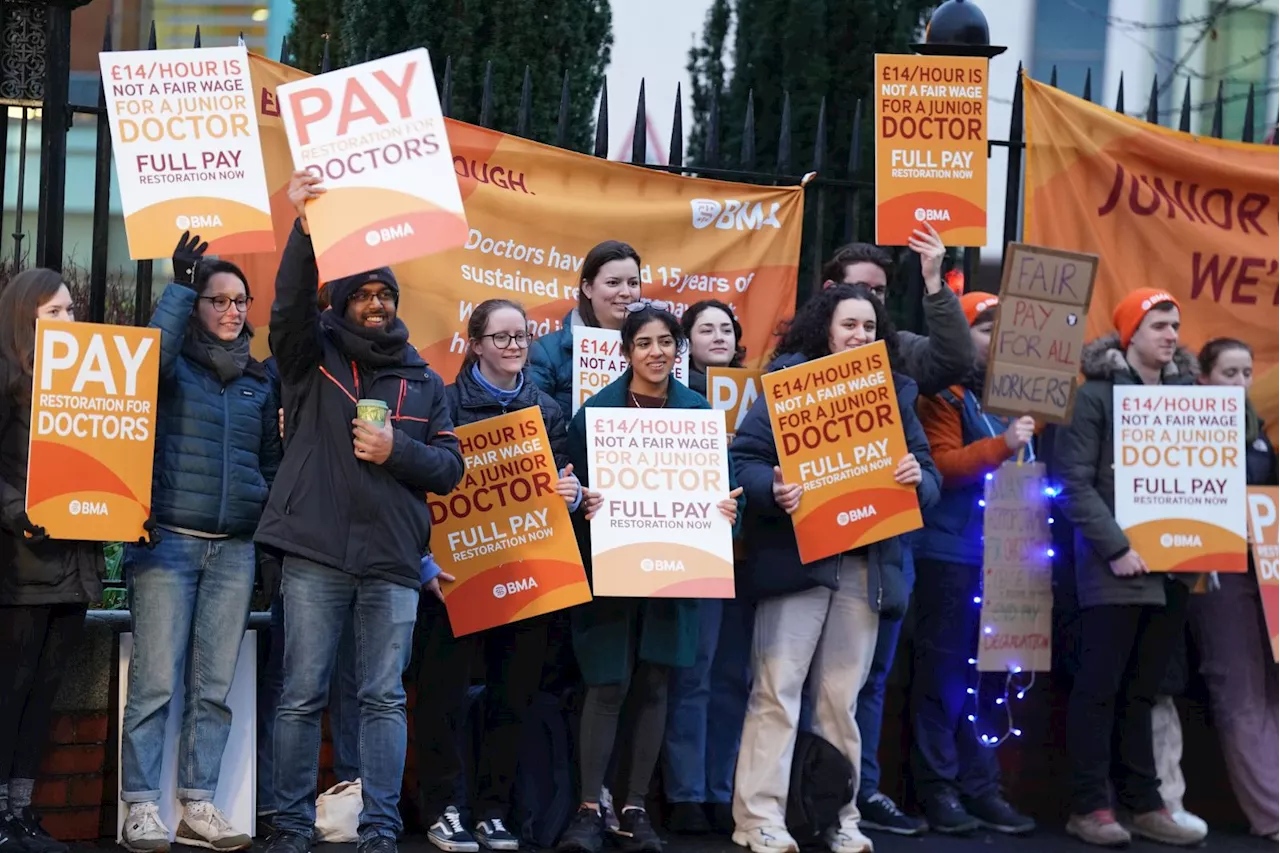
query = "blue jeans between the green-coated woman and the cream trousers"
xmin=662 ymin=599 xmax=755 ymax=803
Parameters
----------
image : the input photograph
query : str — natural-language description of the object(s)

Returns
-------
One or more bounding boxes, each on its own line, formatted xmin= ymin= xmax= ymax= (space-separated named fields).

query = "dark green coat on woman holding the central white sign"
xmin=568 ymin=370 xmax=746 ymax=686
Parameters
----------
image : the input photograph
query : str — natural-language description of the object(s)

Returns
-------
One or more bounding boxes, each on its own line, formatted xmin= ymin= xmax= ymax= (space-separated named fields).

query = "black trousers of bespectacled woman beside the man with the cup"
xmin=413 ymin=593 xmax=549 ymax=821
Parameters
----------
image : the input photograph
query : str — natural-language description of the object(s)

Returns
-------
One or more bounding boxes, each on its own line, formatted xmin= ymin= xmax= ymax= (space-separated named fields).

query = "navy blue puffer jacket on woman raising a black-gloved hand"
xmin=150 ymin=284 xmax=280 ymax=537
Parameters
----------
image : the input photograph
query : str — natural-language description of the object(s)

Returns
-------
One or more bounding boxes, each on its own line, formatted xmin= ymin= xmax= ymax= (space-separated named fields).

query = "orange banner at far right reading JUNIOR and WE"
xmin=1023 ymin=74 xmax=1280 ymax=437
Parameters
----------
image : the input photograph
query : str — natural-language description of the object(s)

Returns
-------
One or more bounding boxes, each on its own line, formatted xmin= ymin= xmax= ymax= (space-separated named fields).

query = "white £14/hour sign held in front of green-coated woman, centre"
xmin=586 ymin=407 xmax=733 ymax=598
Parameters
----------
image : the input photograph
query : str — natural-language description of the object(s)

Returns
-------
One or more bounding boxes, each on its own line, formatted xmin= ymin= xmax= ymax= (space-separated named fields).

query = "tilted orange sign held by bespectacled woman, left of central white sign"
xmin=428 ymin=406 xmax=591 ymax=637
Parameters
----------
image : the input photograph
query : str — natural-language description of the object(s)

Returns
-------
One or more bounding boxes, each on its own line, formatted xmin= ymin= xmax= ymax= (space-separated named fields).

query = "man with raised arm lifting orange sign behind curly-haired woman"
xmin=819 ymin=223 xmax=975 ymax=835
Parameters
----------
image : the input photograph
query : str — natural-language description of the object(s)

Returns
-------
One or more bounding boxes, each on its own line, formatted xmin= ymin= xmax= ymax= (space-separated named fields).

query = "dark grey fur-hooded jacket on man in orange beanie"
xmin=1053 ymin=334 xmax=1198 ymax=608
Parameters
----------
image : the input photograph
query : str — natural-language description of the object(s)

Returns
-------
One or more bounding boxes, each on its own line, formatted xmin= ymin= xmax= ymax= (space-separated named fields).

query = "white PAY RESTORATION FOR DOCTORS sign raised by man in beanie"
xmin=276 ymin=47 xmax=467 ymax=280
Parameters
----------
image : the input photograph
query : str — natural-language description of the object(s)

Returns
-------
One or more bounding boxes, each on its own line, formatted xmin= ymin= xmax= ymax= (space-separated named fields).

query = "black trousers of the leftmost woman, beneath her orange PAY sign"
xmin=0 ymin=605 xmax=86 ymax=784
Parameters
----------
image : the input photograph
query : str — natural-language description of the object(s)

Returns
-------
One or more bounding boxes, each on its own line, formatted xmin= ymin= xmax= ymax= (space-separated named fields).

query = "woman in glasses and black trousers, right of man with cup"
xmin=413 ymin=300 xmax=582 ymax=853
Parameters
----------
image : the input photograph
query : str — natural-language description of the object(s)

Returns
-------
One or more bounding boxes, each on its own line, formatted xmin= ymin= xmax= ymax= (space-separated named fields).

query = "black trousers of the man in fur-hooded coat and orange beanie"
xmin=1066 ymin=580 xmax=1190 ymax=815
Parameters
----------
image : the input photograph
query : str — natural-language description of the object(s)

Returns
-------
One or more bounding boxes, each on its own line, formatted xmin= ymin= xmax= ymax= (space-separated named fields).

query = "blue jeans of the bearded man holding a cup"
xmin=275 ymin=556 xmax=417 ymax=841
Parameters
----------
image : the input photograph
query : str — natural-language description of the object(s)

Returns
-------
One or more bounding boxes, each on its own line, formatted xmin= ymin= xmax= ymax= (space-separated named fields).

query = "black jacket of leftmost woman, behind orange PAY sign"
xmin=0 ymin=357 xmax=106 ymax=606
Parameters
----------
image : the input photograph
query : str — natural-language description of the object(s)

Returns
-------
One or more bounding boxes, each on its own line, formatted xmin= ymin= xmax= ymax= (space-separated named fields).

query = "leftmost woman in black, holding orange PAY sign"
xmin=0 ymin=269 xmax=106 ymax=853
